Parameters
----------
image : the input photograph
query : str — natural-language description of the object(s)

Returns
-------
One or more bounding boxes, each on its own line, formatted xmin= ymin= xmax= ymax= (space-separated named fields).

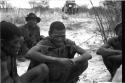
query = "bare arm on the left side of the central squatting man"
xmin=25 ymin=45 xmax=73 ymax=68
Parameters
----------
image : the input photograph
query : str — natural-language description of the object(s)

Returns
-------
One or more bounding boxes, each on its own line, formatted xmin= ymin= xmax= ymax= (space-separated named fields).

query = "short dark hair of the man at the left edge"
xmin=0 ymin=21 xmax=21 ymax=41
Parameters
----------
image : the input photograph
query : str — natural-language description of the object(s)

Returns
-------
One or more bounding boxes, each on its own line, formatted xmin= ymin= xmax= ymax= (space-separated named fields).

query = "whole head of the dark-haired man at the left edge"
xmin=0 ymin=21 xmax=22 ymax=54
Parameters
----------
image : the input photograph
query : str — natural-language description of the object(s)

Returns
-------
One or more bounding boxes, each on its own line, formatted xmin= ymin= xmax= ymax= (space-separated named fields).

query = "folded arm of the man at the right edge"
xmin=96 ymin=43 xmax=122 ymax=56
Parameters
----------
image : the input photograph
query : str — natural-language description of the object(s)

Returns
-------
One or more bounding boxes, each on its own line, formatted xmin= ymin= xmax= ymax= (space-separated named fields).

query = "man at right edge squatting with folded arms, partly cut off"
xmin=97 ymin=23 xmax=122 ymax=79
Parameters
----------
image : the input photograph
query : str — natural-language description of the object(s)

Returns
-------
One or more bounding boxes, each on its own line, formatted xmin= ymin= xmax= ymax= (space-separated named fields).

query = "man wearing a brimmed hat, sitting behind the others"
xmin=19 ymin=13 xmax=44 ymax=61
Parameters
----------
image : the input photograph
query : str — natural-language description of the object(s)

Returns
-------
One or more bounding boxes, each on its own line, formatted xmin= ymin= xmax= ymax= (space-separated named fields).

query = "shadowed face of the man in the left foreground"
xmin=6 ymin=36 xmax=23 ymax=55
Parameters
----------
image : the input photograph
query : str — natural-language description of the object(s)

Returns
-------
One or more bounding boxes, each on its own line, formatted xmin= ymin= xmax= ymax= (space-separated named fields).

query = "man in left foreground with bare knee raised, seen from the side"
xmin=0 ymin=21 xmax=48 ymax=83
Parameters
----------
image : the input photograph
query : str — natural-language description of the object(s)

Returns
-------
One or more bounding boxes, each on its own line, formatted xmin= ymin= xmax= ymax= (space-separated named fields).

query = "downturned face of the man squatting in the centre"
xmin=50 ymin=30 xmax=65 ymax=47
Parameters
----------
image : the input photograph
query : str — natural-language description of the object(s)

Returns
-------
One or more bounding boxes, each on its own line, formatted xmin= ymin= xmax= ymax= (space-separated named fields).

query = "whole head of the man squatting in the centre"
xmin=49 ymin=21 xmax=66 ymax=47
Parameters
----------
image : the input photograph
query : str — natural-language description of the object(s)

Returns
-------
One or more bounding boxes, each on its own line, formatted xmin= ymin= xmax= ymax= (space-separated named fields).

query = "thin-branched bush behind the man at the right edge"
xmin=89 ymin=1 xmax=121 ymax=43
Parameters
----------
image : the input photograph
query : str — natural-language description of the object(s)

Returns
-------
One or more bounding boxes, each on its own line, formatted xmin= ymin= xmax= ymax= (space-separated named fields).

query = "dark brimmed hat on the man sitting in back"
xmin=25 ymin=13 xmax=41 ymax=23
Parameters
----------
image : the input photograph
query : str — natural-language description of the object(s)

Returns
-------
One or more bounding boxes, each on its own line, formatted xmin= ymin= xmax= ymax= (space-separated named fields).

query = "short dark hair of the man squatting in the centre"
xmin=49 ymin=21 xmax=65 ymax=33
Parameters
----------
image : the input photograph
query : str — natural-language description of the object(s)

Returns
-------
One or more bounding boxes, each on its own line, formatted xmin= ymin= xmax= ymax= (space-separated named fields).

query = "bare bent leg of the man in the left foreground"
xmin=20 ymin=64 xmax=48 ymax=83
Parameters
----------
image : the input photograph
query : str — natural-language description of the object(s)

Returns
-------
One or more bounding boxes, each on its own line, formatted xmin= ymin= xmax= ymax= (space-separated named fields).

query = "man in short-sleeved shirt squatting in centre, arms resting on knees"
xmin=27 ymin=21 xmax=92 ymax=83
